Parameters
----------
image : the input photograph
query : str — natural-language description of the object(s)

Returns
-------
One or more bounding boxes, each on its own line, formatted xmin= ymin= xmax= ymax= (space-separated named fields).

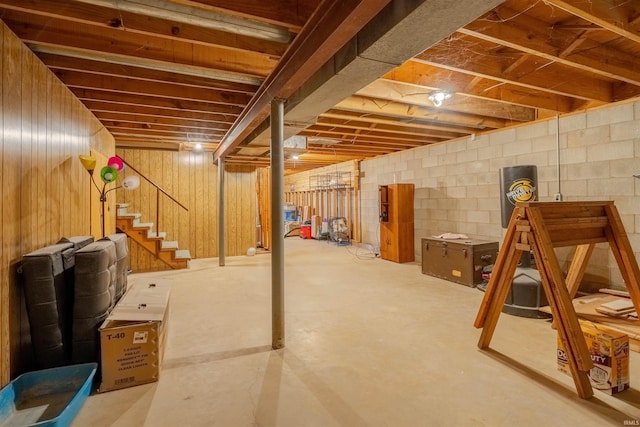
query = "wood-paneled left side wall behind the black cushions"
xmin=0 ymin=22 xmax=114 ymax=386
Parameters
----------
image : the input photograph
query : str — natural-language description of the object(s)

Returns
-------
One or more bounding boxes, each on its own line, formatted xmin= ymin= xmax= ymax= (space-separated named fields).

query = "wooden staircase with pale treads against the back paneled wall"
xmin=116 ymin=203 xmax=191 ymax=270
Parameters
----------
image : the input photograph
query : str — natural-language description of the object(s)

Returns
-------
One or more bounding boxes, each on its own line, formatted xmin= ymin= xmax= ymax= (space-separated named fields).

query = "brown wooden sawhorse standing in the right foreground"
xmin=474 ymin=201 xmax=640 ymax=399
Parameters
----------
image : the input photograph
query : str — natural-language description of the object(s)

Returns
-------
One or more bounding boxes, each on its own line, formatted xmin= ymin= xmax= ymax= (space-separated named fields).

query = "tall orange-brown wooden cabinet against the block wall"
xmin=379 ymin=184 xmax=415 ymax=262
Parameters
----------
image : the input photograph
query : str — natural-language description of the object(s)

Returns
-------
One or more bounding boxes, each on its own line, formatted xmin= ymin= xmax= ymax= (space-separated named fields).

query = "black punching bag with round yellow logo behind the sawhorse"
xmin=500 ymin=165 xmax=538 ymax=228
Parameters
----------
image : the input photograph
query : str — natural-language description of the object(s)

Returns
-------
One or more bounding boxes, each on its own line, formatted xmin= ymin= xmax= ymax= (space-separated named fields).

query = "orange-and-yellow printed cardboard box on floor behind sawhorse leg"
xmin=558 ymin=320 xmax=629 ymax=394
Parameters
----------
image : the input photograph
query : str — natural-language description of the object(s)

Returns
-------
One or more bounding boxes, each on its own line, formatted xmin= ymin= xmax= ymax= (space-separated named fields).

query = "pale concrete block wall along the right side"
xmin=360 ymin=101 xmax=640 ymax=290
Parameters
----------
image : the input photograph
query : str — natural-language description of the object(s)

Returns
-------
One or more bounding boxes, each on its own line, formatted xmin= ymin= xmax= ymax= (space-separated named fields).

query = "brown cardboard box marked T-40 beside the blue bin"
xmin=98 ymin=279 xmax=171 ymax=392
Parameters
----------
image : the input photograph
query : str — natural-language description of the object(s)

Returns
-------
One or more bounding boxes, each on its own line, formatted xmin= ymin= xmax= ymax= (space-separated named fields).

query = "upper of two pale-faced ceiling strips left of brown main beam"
xmin=76 ymin=0 xmax=292 ymax=43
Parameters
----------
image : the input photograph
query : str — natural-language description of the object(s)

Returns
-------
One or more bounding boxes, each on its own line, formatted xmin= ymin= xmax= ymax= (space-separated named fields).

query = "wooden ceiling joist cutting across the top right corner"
xmin=545 ymin=0 xmax=640 ymax=43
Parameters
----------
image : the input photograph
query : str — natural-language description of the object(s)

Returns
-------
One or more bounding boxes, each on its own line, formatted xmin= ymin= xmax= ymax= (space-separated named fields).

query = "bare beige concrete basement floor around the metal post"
xmin=73 ymin=237 xmax=640 ymax=427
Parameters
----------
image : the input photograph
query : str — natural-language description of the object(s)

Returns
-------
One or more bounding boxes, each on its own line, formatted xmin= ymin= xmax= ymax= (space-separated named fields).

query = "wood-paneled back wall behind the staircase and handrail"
xmin=117 ymin=149 xmax=256 ymax=271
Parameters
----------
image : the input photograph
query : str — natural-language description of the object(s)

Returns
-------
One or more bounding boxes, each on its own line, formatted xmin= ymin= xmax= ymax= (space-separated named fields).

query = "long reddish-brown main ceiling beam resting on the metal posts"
xmin=214 ymin=0 xmax=390 ymax=161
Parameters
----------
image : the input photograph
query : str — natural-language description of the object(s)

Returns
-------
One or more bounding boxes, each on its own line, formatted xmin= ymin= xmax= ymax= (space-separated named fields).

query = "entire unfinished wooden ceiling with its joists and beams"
xmin=0 ymin=0 xmax=640 ymax=164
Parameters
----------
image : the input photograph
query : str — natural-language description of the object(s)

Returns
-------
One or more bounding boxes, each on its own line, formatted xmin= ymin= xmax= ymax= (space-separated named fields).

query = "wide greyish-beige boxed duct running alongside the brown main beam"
xmin=238 ymin=0 xmax=502 ymax=149
